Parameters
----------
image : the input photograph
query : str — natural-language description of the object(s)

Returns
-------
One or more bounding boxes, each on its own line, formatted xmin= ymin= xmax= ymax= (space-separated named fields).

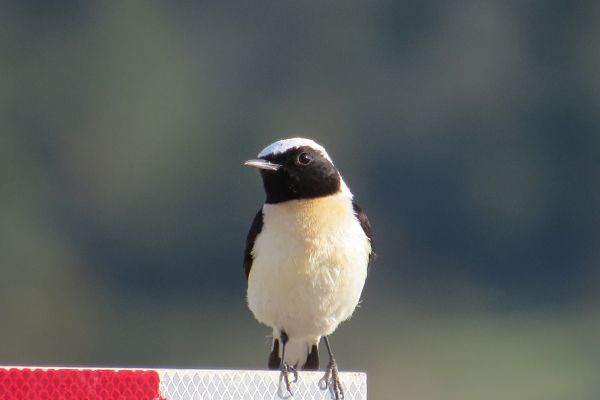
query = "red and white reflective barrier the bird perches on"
xmin=0 ymin=367 xmax=367 ymax=400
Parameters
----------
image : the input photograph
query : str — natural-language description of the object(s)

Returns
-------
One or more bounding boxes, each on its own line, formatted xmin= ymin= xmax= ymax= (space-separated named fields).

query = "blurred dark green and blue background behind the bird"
xmin=0 ymin=0 xmax=600 ymax=400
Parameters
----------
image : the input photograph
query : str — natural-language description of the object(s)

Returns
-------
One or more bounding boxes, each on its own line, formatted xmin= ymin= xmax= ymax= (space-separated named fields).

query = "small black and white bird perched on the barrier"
xmin=244 ymin=138 xmax=374 ymax=399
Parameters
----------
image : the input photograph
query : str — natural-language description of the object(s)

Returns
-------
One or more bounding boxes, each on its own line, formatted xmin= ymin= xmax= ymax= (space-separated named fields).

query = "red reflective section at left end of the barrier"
xmin=0 ymin=368 xmax=164 ymax=400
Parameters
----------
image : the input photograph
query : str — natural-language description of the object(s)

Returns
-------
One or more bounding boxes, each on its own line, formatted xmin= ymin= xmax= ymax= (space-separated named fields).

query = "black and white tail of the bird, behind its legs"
xmin=269 ymin=337 xmax=319 ymax=370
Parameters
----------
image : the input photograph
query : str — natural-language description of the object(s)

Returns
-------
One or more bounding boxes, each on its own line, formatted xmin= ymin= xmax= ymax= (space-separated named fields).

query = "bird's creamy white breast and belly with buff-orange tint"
xmin=248 ymin=193 xmax=371 ymax=338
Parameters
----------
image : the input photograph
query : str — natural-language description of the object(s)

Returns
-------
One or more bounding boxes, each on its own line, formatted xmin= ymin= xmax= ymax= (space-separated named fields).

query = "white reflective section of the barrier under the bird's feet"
xmin=157 ymin=369 xmax=367 ymax=400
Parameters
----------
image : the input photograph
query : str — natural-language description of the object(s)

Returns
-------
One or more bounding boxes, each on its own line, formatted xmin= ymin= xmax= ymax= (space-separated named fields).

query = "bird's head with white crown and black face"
xmin=244 ymin=138 xmax=349 ymax=204
